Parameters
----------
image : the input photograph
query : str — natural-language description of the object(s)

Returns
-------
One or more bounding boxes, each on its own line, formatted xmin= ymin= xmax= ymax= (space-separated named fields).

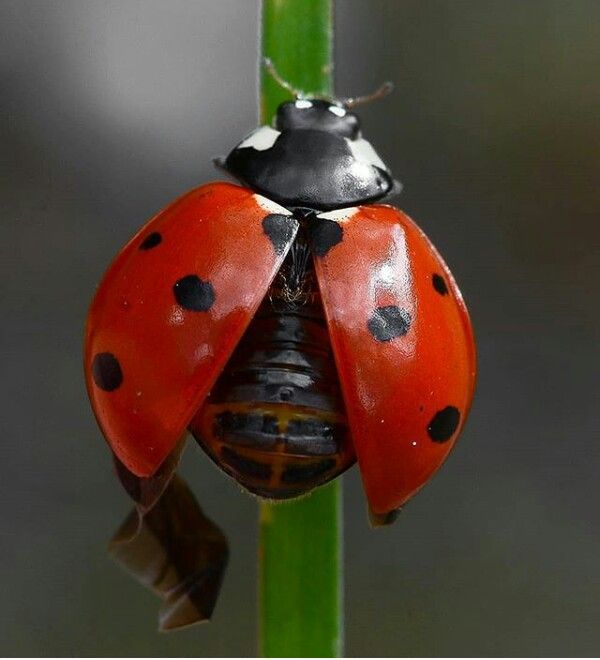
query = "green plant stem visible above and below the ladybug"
xmin=259 ymin=0 xmax=342 ymax=657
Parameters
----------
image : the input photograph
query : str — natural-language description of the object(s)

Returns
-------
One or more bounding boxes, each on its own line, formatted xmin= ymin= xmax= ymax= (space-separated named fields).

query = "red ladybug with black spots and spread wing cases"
xmin=85 ymin=90 xmax=475 ymax=628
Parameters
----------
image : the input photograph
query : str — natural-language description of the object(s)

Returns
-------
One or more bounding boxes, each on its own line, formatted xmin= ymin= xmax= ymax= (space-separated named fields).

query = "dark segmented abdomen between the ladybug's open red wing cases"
xmin=190 ymin=245 xmax=355 ymax=499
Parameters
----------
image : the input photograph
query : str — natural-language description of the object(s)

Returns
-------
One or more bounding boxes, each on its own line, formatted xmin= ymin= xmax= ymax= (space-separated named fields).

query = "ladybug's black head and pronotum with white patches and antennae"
xmin=224 ymin=64 xmax=401 ymax=210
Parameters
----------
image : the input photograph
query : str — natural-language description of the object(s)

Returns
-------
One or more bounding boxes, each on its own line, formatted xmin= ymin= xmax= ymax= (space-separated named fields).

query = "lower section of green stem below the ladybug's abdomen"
xmin=259 ymin=479 xmax=343 ymax=658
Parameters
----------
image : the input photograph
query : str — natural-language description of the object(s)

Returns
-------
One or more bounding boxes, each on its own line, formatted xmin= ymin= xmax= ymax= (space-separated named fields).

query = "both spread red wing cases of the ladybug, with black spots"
xmin=85 ymin=183 xmax=475 ymax=515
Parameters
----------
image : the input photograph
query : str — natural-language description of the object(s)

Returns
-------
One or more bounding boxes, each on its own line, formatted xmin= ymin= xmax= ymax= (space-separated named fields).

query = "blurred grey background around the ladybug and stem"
xmin=0 ymin=0 xmax=600 ymax=656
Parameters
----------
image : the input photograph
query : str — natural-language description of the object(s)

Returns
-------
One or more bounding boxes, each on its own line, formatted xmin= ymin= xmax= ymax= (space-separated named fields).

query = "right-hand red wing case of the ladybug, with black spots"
xmin=315 ymin=205 xmax=475 ymax=515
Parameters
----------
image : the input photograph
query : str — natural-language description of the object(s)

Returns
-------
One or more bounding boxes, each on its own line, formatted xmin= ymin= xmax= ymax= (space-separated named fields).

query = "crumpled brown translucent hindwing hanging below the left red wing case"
xmin=109 ymin=445 xmax=229 ymax=631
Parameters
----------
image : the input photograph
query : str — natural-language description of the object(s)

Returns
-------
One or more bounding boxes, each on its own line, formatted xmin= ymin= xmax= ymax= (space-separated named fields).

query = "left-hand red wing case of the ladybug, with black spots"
xmin=85 ymin=183 xmax=297 ymax=477
